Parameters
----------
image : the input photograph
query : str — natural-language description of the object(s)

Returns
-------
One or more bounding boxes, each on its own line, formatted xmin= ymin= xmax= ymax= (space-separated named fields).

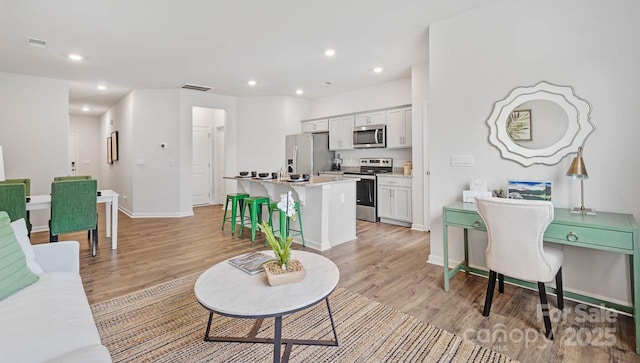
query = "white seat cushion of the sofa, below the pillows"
xmin=0 ymin=272 xmax=110 ymax=362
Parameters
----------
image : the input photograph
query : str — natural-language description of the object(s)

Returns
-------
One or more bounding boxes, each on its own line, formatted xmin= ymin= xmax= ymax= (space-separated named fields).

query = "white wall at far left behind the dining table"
xmin=0 ymin=72 xmax=69 ymax=231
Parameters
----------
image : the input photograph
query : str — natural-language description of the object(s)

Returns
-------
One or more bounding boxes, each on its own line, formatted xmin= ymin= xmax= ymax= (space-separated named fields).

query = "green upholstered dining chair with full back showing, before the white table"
xmin=49 ymin=179 xmax=98 ymax=256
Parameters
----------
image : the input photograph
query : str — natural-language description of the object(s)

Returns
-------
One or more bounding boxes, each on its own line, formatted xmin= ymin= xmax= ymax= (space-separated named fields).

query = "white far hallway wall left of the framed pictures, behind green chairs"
xmin=69 ymin=115 xmax=101 ymax=188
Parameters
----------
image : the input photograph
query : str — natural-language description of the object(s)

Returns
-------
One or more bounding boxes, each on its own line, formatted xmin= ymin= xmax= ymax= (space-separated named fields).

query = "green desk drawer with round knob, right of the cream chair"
xmin=544 ymin=223 xmax=633 ymax=251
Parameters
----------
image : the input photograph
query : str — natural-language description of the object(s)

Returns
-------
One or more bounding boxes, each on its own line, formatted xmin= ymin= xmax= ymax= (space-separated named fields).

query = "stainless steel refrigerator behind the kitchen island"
xmin=285 ymin=132 xmax=334 ymax=175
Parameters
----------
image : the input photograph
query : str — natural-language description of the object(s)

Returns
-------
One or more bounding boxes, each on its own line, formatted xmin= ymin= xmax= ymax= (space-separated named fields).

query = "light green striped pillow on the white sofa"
xmin=0 ymin=211 xmax=38 ymax=301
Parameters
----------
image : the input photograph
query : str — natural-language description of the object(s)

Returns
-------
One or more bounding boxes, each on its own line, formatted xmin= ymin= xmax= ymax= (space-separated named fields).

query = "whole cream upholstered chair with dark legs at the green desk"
xmin=476 ymin=198 xmax=564 ymax=340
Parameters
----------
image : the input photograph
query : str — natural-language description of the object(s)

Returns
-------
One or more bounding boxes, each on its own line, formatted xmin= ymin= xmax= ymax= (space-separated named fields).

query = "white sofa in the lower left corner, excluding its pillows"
xmin=0 ymin=241 xmax=111 ymax=363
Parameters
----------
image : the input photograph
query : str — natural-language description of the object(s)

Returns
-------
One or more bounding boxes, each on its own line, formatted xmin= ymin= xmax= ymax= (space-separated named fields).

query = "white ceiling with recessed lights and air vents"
xmin=0 ymin=0 xmax=494 ymax=115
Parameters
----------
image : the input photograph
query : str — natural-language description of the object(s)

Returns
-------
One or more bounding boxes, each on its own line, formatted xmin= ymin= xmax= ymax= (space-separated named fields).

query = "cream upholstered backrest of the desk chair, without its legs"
xmin=476 ymin=198 xmax=556 ymax=282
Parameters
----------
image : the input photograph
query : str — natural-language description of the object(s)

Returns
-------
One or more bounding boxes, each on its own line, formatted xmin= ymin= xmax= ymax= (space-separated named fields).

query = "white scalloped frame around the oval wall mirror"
xmin=487 ymin=81 xmax=595 ymax=166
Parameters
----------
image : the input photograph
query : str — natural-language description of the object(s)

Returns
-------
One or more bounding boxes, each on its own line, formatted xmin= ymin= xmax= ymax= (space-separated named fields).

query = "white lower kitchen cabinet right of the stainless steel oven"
xmin=377 ymin=175 xmax=411 ymax=227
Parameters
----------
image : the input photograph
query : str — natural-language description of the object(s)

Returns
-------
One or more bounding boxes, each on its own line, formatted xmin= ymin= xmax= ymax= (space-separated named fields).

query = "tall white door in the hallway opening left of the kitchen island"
xmin=192 ymin=126 xmax=211 ymax=205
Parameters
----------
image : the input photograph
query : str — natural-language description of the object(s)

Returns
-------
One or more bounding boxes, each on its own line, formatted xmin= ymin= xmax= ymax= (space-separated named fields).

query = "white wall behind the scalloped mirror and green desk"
xmin=428 ymin=0 xmax=640 ymax=303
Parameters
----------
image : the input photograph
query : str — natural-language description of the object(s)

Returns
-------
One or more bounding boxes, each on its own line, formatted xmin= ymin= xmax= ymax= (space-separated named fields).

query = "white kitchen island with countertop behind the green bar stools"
xmin=225 ymin=175 xmax=357 ymax=251
